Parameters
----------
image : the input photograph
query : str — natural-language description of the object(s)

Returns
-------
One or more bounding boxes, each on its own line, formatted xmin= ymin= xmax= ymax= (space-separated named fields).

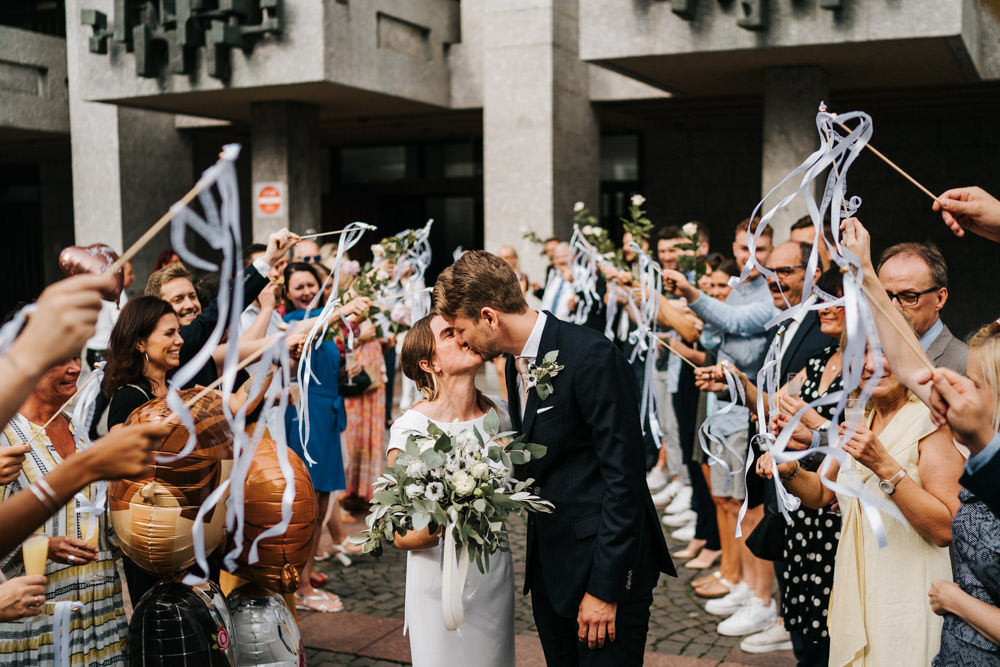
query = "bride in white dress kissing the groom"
xmin=387 ymin=313 xmax=514 ymax=667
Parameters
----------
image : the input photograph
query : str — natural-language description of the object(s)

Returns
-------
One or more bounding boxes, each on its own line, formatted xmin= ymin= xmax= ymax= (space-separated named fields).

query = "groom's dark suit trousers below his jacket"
xmin=531 ymin=582 xmax=653 ymax=667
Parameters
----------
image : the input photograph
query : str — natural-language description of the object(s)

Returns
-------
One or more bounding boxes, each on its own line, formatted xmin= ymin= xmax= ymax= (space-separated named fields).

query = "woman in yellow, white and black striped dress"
xmin=0 ymin=359 xmax=128 ymax=667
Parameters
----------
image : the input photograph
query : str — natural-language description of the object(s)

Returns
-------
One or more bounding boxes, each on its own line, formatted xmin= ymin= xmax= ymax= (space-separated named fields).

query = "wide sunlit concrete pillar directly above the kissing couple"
xmin=483 ymin=0 xmax=600 ymax=277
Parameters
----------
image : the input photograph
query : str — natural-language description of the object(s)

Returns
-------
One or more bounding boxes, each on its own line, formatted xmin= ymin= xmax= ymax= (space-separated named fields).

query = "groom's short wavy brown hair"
xmin=434 ymin=250 xmax=528 ymax=320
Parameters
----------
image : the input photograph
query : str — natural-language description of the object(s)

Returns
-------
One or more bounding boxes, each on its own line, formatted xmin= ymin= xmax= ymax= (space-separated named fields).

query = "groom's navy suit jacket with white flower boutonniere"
xmin=506 ymin=313 xmax=676 ymax=618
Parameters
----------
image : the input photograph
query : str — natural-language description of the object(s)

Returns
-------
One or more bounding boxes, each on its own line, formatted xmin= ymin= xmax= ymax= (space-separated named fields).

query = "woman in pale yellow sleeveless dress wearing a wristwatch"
xmin=758 ymin=353 xmax=963 ymax=667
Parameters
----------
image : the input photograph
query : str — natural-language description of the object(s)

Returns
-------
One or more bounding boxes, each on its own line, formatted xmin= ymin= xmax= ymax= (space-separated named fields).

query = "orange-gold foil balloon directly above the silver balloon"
xmin=236 ymin=437 xmax=317 ymax=593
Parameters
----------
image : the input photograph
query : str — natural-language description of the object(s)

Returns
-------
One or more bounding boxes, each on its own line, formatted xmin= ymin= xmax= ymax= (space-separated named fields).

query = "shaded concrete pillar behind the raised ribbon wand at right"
xmin=761 ymin=67 xmax=830 ymax=243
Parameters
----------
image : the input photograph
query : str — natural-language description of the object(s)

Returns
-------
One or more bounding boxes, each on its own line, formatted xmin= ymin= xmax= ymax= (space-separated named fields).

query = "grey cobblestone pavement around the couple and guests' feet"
xmin=307 ymin=508 xmax=794 ymax=667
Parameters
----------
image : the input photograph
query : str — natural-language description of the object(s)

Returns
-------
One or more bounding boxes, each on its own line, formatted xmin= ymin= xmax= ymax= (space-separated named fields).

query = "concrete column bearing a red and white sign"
xmin=250 ymin=102 xmax=323 ymax=240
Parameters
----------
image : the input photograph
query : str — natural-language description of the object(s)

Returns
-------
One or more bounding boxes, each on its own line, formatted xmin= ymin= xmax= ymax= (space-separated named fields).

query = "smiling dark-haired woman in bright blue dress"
xmin=285 ymin=262 xmax=369 ymax=612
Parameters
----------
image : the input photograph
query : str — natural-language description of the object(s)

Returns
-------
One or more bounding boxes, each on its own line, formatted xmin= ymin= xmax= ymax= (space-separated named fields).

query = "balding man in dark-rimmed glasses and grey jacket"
xmin=877 ymin=242 xmax=969 ymax=375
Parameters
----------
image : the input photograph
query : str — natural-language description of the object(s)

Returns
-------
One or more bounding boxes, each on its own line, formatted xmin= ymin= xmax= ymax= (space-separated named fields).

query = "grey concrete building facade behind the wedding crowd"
xmin=0 ymin=0 xmax=1000 ymax=331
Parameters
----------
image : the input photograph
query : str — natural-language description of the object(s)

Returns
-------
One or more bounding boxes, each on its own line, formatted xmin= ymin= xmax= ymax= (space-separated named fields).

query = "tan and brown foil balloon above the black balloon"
xmin=108 ymin=389 xmax=233 ymax=575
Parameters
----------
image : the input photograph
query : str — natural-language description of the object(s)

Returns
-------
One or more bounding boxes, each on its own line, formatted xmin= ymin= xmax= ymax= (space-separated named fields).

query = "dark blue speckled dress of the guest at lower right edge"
xmin=932 ymin=489 xmax=1000 ymax=667
